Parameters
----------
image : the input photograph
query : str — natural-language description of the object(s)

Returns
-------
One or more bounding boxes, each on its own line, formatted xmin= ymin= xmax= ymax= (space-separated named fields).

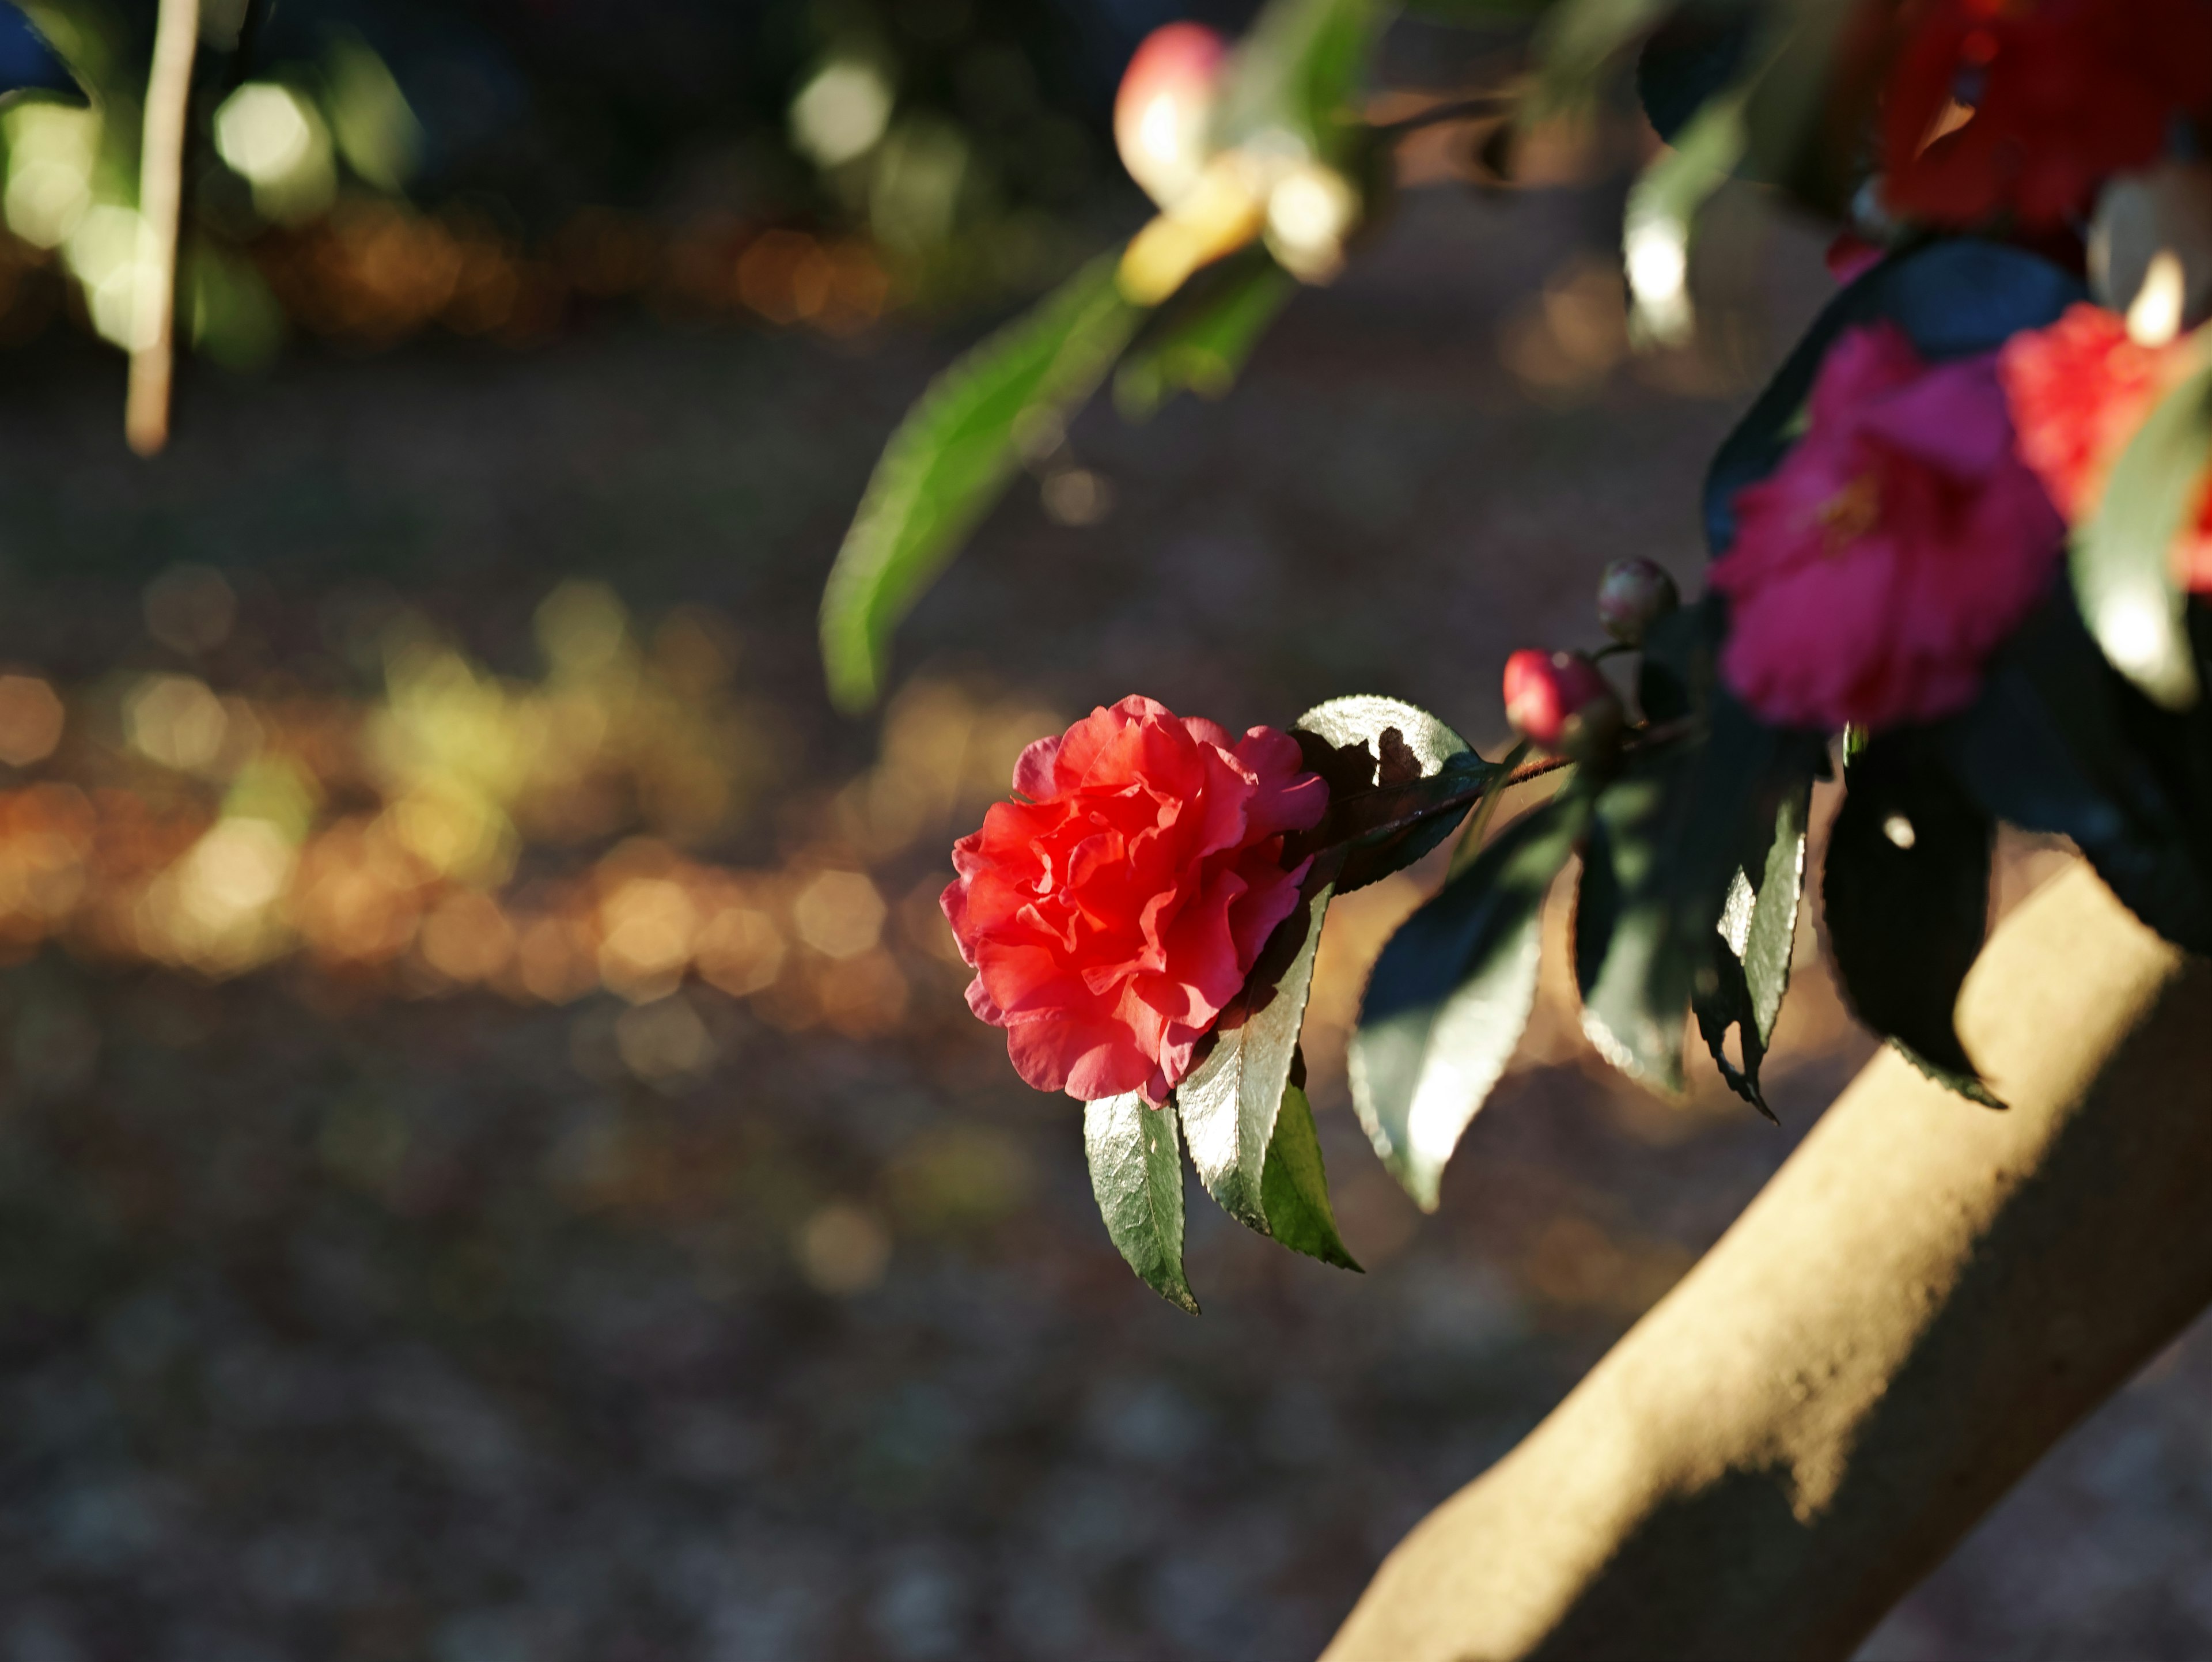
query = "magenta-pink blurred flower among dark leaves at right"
xmin=1712 ymin=323 xmax=2066 ymax=730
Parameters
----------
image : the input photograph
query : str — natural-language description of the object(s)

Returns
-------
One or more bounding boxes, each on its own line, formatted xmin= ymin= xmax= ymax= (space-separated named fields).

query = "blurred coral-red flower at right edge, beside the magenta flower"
xmin=1998 ymin=303 xmax=2212 ymax=593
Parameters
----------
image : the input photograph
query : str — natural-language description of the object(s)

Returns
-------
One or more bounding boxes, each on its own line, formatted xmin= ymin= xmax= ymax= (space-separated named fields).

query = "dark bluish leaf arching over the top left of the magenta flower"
xmin=1706 ymin=237 xmax=2088 ymax=555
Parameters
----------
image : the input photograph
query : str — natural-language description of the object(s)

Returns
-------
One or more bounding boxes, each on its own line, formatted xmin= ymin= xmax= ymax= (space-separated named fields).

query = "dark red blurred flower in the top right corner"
xmin=1883 ymin=0 xmax=2212 ymax=228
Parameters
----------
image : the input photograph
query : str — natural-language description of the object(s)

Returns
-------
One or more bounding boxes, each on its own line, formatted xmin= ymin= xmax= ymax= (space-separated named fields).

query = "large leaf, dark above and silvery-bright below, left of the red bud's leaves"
xmin=1349 ymin=794 xmax=1588 ymax=1210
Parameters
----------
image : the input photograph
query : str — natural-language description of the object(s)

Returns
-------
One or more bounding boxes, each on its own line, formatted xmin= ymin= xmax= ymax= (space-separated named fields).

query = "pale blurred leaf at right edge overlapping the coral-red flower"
xmin=2070 ymin=347 xmax=2212 ymax=710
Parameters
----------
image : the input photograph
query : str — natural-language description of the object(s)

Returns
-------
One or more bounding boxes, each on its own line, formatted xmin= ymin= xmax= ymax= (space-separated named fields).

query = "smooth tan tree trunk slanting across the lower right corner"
xmin=1325 ymin=868 xmax=2212 ymax=1662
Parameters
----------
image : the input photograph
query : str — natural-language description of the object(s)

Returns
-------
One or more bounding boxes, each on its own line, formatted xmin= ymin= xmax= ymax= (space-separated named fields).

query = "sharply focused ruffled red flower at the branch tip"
xmin=942 ymin=697 xmax=1330 ymax=1107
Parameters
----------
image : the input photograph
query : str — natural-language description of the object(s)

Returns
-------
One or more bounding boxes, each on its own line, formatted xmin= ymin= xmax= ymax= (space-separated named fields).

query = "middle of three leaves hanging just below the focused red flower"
xmin=1175 ymin=885 xmax=1332 ymax=1235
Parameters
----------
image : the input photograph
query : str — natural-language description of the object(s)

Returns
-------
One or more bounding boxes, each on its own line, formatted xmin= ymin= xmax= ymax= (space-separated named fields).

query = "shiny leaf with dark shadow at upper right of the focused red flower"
xmin=1285 ymin=692 xmax=1500 ymax=894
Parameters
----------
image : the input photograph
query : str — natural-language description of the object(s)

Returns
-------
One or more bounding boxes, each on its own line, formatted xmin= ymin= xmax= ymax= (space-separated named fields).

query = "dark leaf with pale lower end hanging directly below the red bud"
xmin=1575 ymin=695 xmax=1814 ymax=1093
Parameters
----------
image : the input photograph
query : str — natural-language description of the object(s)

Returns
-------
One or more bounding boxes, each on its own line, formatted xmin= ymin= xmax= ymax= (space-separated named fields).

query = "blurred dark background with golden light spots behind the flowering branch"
xmin=0 ymin=0 xmax=2212 ymax=1662
